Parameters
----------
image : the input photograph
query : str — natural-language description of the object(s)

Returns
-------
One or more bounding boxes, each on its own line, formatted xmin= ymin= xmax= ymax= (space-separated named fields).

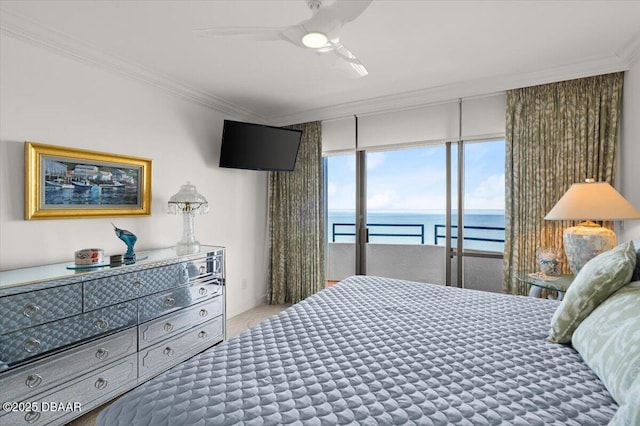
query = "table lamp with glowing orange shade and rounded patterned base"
xmin=544 ymin=179 xmax=640 ymax=275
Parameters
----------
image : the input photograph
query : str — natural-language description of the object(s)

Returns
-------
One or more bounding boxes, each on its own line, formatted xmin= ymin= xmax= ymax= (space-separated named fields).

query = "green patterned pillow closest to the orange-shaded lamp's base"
xmin=549 ymin=241 xmax=636 ymax=343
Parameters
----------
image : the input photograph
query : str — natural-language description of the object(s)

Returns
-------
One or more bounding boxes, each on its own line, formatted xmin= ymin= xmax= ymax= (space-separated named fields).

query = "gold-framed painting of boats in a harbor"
xmin=24 ymin=142 xmax=151 ymax=220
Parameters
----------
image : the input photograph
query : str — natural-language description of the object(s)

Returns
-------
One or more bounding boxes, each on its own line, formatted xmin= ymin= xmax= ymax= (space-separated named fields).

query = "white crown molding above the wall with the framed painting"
xmin=0 ymin=8 xmax=264 ymax=121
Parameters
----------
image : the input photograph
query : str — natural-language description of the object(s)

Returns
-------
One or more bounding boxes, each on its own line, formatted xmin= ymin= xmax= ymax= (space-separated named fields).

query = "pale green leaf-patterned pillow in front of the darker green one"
xmin=571 ymin=281 xmax=640 ymax=404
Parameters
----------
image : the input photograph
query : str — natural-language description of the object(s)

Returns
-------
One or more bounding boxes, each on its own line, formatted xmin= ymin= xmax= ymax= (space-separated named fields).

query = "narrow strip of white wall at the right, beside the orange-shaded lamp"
xmin=618 ymin=59 xmax=640 ymax=241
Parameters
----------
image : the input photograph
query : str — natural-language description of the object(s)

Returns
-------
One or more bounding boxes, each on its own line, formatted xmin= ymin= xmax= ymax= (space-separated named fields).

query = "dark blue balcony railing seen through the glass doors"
xmin=331 ymin=223 xmax=504 ymax=245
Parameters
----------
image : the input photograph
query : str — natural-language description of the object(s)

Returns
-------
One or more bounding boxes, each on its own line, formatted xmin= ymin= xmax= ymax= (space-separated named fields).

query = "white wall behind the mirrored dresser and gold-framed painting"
xmin=0 ymin=35 xmax=267 ymax=316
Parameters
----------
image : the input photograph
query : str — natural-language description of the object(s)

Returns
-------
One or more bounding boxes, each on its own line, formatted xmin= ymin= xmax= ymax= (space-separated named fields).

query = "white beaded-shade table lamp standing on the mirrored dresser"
xmin=168 ymin=182 xmax=209 ymax=254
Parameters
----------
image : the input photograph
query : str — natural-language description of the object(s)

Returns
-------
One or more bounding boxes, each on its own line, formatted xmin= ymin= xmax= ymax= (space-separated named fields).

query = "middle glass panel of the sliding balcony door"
xmin=366 ymin=145 xmax=447 ymax=284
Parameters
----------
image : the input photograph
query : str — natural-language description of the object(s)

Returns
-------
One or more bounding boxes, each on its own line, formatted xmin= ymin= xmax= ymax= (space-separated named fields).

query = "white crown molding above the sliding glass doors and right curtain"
xmin=267 ymin=53 xmax=640 ymax=126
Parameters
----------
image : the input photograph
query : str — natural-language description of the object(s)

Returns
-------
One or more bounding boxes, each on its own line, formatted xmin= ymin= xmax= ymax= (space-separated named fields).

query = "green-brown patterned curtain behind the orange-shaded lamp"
xmin=503 ymin=73 xmax=623 ymax=294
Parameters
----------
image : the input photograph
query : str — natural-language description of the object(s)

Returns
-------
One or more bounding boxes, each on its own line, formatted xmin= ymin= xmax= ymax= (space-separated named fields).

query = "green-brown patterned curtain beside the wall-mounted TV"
xmin=269 ymin=122 xmax=324 ymax=304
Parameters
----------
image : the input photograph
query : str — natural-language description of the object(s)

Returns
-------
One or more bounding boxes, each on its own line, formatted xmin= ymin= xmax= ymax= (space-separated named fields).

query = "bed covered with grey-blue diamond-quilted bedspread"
xmin=97 ymin=276 xmax=618 ymax=426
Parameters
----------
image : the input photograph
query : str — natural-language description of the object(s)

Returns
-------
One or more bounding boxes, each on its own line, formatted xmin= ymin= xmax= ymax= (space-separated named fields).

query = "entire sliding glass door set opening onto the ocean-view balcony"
xmin=325 ymin=140 xmax=504 ymax=291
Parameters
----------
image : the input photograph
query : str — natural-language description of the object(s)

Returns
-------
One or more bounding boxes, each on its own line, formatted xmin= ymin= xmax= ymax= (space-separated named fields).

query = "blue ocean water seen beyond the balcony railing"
xmin=327 ymin=210 xmax=504 ymax=252
